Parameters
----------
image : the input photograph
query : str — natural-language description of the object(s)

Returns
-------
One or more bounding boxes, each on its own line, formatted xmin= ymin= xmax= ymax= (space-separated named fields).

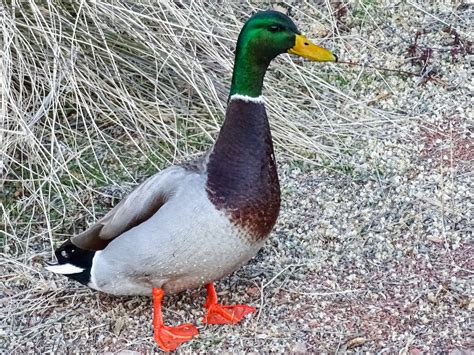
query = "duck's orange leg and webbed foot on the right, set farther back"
xmin=202 ymin=283 xmax=256 ymax=324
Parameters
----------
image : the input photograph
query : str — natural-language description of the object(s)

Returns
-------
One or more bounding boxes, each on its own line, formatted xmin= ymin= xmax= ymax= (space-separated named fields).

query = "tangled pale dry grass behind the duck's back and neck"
xmin=1 ymin=2 xmax=404 ymax=251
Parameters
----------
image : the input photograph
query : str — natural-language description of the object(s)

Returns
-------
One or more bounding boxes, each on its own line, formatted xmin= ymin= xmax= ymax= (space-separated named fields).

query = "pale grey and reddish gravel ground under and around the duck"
xmin=0 ymin=2 xmax=474 ymax=354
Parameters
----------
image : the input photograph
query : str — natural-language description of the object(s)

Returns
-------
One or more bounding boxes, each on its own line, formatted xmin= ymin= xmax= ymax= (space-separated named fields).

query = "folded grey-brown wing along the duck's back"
xmin=71 ymin=166 xmax=193 ymax=250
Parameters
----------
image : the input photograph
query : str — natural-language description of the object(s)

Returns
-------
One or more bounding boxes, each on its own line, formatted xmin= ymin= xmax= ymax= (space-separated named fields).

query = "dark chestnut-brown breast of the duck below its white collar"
xmin=207 ymin=100 xmax=280 ymax=241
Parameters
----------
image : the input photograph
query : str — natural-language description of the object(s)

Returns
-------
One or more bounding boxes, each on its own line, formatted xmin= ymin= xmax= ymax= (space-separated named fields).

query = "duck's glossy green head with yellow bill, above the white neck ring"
xmin=230 ymin=10 xmax=337 ymax=97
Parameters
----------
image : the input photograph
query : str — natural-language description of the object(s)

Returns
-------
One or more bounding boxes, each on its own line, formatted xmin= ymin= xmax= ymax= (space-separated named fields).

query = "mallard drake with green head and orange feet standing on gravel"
xmin=47 ymin=11 xmax=336 ymax=351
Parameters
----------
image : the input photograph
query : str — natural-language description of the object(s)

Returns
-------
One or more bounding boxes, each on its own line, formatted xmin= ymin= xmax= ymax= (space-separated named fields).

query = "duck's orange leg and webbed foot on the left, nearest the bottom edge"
xmin=153 ymin=288 xmax=198 ymax=351
